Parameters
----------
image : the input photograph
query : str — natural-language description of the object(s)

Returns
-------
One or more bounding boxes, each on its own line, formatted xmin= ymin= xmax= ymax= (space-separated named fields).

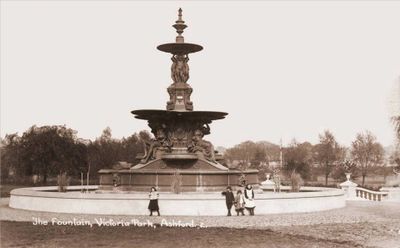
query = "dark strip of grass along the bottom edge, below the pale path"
xmin=0 ymin=221 xmax=362 ymax=248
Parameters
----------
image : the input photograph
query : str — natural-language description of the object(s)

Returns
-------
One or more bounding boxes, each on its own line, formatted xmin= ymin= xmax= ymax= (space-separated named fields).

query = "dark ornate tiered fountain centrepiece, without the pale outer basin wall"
xmin=99 ymin=9 xmax=258 ymax=191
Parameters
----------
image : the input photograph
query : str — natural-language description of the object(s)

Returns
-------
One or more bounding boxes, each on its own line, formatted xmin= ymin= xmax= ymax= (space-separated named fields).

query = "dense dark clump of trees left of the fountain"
xmin=0 ymin=126 xmax=151 ymax=183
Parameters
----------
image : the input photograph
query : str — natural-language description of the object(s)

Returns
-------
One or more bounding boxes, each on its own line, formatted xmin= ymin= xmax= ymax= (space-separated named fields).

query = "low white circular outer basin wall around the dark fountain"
xmin=9 ymin=186 xmax=346 ymax=216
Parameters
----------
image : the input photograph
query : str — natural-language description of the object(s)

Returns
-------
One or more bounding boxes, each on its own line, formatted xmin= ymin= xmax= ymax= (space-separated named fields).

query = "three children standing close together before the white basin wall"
xmin=222 ymin=184 xmax=256 ymax=216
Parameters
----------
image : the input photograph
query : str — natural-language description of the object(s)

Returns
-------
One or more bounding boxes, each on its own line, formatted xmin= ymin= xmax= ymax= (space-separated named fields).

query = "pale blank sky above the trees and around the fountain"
xmin=0 ymin=1 xmax=400 ymax=147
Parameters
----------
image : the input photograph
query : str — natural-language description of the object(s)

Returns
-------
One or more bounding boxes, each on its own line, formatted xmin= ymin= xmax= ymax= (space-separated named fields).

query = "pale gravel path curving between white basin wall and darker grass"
xmin=0 ymin=198 xmax=400 ymax=248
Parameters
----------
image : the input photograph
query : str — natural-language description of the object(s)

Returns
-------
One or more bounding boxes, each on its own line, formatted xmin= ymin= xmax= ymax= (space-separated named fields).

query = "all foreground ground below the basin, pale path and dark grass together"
xmin=0 ymin=194 xmax=400 ymax=248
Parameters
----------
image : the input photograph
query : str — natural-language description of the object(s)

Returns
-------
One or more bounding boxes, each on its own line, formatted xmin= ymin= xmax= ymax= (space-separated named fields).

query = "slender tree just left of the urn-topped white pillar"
xmin=314 ymin=130 xmax=344 ymax=185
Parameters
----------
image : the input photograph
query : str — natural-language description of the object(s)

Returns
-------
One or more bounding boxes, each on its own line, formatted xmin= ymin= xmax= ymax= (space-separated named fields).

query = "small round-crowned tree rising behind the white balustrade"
xmin=351 ymin=131 xmax=384 ymax=186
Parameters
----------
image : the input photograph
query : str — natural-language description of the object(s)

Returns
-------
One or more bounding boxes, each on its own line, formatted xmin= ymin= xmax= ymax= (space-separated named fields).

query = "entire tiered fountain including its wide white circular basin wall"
xmin=9 ymin=10 xmax=346 ymax=216
